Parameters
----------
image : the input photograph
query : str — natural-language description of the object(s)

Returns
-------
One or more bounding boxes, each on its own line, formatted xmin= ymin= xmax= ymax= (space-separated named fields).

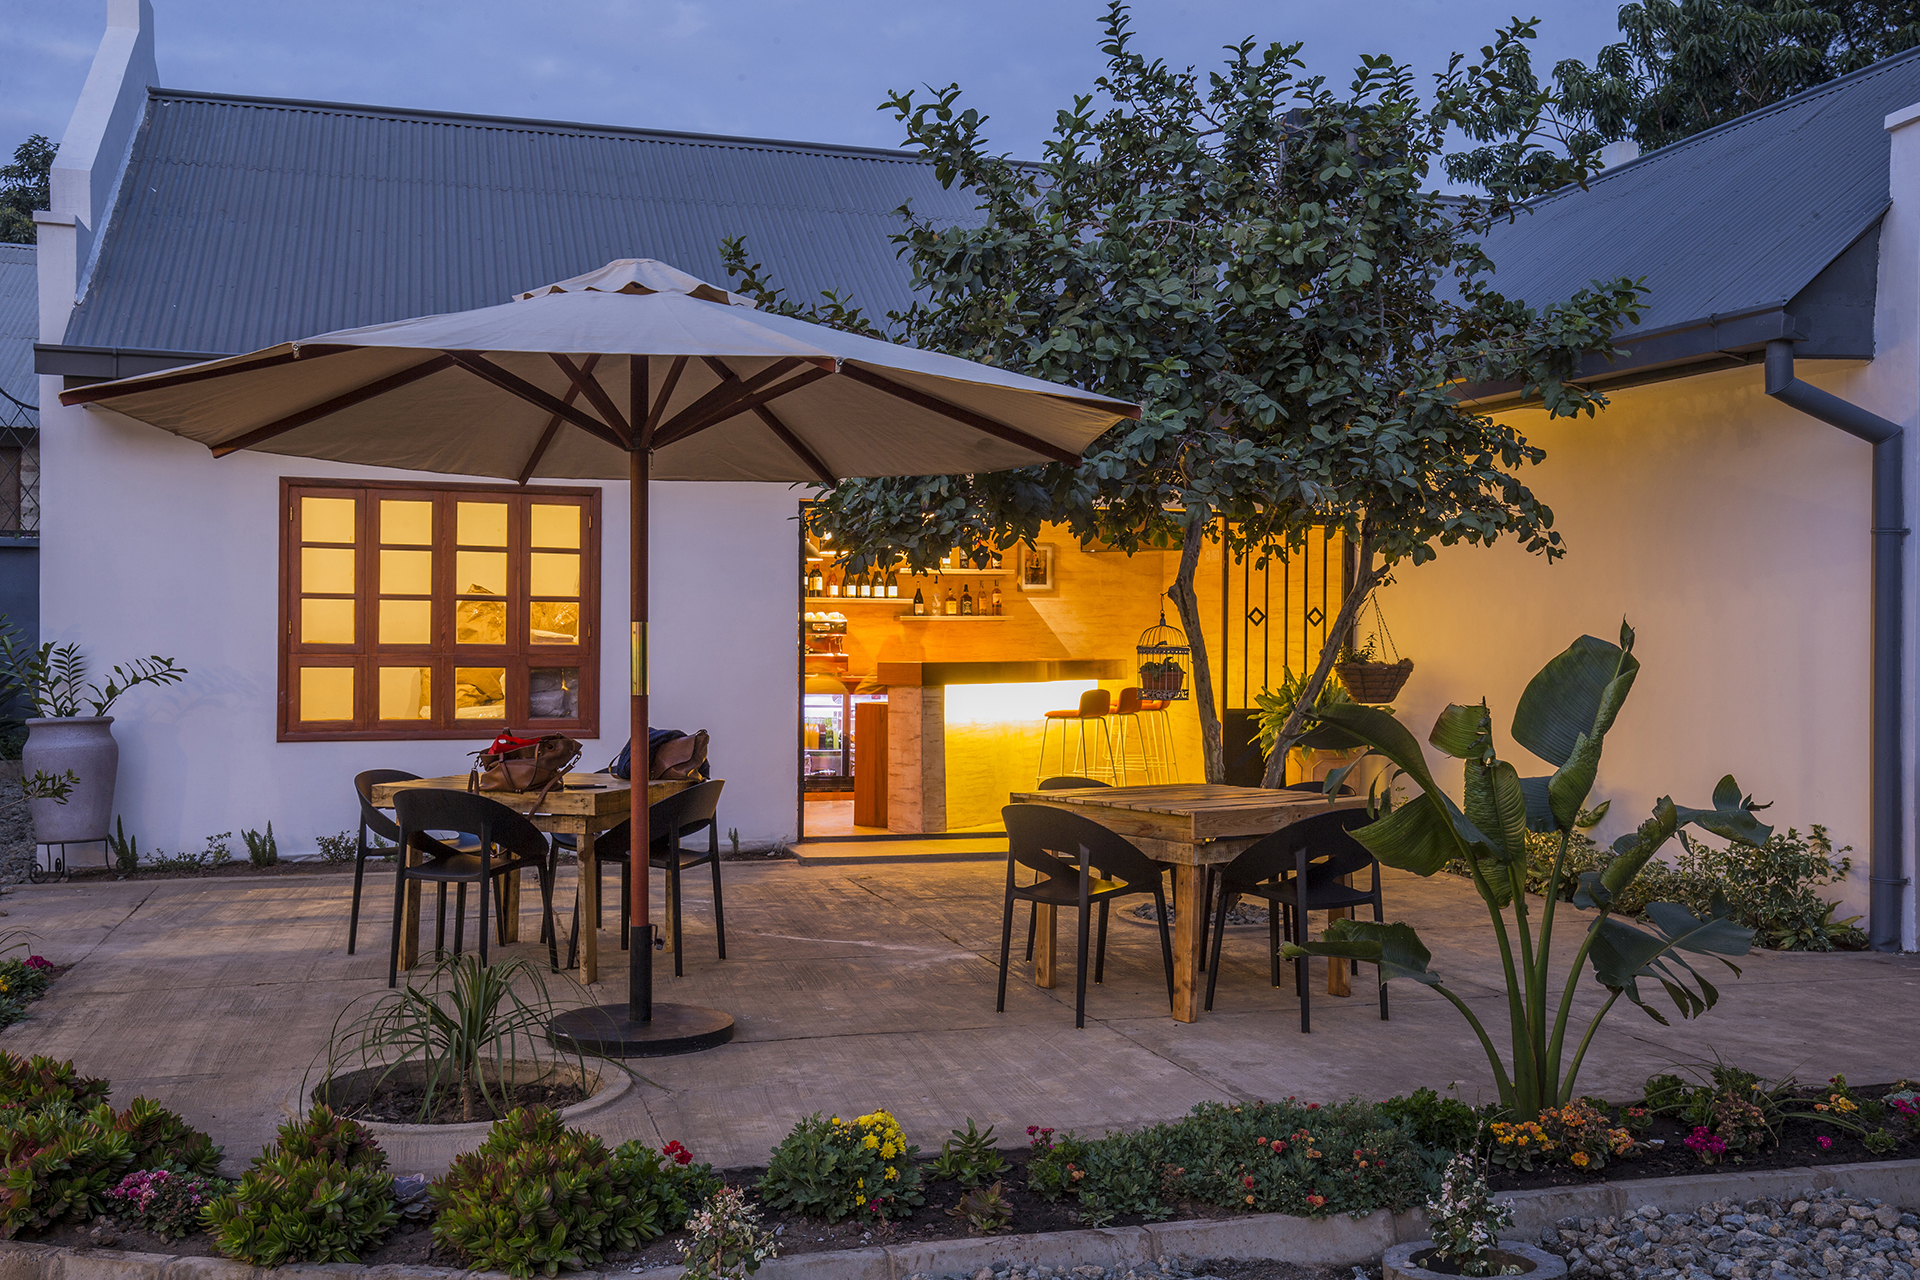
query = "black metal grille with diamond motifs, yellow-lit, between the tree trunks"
xmin=1221 ymin=530 xmax=1348 ymax=712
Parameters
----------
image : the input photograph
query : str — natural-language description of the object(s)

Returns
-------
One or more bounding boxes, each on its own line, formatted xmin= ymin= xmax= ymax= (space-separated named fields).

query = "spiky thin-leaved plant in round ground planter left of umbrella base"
xmin=323 ymin=954 xmax=582 ymax=1123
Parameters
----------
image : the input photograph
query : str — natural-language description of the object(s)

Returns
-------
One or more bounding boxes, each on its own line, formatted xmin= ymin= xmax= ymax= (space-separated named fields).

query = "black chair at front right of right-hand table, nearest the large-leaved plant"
xmin=1206 ymin=810 xmax=1386 ymax=1032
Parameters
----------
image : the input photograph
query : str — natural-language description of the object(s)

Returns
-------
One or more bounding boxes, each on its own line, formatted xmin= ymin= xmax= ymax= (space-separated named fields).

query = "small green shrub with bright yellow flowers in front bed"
xmin=760 ymin=1111 xmax=925 ymax=1222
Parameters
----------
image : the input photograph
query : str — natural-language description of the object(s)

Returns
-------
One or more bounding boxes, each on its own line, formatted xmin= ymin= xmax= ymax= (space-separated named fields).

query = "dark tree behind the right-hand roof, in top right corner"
xmin=1448 ymin=0 xmax=1920 ymax=196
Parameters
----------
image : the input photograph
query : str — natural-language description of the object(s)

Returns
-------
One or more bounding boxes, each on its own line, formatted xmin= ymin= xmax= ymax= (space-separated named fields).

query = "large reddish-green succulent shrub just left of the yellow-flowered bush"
xmin=432 ymin=1107 xmax=720 ymax=1276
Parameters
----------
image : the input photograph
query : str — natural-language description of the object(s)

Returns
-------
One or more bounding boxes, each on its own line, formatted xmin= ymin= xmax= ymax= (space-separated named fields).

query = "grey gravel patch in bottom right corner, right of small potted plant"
xmin=1540 ymin=1186 xmax=1920 ymax=1280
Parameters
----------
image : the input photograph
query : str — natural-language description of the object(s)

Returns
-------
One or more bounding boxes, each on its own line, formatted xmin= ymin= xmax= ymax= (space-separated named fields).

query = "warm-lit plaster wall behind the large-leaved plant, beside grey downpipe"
xmin=1380 ymin=361 xmax=1891 ymax=923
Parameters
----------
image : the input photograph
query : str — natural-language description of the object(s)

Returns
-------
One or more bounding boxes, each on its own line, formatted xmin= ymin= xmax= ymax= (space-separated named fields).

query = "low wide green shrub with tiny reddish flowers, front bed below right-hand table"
xmin=1029 ymin=1102 xmax=1450 ymax=1222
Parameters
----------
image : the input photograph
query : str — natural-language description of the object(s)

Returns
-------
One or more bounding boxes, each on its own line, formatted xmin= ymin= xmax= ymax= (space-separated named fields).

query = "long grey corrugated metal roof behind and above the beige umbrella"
xmin=65 ymin=90 xmax=975 ymax=351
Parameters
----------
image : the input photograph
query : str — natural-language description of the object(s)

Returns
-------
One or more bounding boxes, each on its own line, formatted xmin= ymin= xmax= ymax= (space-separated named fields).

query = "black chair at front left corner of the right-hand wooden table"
xmin=995 ymin=804 xmax=1173 ymax=1029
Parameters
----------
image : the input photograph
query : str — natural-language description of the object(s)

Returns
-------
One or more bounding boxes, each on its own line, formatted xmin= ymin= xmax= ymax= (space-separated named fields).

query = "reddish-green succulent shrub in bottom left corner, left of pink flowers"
xmin=0 ymin=1080 xmax=221 ymax=1238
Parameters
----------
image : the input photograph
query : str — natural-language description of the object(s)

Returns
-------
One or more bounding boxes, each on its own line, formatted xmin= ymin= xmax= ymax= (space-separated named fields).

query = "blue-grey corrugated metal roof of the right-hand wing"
xmin=1486 ymin=50 xmax=1920 ymax=345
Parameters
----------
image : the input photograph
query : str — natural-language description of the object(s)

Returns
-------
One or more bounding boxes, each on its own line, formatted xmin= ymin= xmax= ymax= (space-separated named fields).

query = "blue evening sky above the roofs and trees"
xmin=0 ymin=0 xmax=1615 ymax=155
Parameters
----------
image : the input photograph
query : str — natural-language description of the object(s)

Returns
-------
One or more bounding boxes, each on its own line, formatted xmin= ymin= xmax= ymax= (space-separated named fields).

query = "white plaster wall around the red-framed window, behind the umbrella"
xmin=40 ymin=387 xmax=799 ymax=854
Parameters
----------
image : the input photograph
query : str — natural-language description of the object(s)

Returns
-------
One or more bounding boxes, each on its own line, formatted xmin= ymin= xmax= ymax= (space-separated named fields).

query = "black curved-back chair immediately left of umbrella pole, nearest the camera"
xmin=386 ymin=787 xmax=561 ymax=986
